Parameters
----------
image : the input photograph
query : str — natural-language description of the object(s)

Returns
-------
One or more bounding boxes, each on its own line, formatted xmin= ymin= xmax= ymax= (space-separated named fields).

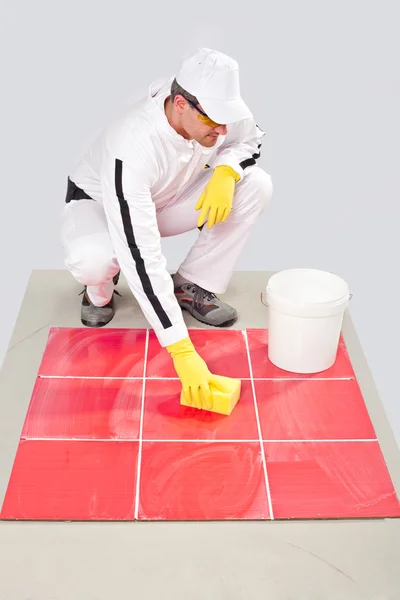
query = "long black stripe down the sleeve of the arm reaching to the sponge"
xmin=115 ymin=158 xmax=172 ymax=329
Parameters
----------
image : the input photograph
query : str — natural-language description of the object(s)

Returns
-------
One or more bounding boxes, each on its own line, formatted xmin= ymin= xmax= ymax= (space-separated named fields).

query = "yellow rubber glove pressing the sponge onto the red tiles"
xmin=166 ymin=337 xmax=220 ymax=410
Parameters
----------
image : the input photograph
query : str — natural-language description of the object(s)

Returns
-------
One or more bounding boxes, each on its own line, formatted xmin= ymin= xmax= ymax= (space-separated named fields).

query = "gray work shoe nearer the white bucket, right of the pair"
xmin=174 ymin=282 xmax=238 ymax=327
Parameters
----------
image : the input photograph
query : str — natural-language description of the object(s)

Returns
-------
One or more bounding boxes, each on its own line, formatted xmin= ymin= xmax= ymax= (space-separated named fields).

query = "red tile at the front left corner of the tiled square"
xmin=1 ymin=441 xmax=139 ymax=521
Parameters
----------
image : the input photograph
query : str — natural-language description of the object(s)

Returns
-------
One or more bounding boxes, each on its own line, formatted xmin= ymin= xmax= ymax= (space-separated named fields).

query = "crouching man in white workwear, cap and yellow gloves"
xmin=62 ymin=48 xmax=273 ymax=407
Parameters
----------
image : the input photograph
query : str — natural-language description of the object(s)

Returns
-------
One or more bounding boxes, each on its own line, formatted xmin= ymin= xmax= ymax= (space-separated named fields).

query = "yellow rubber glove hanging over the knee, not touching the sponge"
xmin=196 ymin=165 xmax=240 ymax=229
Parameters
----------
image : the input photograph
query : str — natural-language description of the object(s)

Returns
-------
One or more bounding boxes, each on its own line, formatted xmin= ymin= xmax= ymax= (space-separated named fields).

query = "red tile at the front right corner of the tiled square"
xmin=264 ymin=442 xmax=400 ymax=519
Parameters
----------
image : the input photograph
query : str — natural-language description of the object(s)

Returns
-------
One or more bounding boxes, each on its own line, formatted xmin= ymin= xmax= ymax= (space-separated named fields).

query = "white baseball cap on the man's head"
xmin=176 ymin=48 xmax=253 ymax=125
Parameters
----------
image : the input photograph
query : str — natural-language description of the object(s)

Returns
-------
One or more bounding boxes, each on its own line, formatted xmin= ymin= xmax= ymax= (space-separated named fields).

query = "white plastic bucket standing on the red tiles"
xmin=266 ymin=269 xmax=351 ymax=373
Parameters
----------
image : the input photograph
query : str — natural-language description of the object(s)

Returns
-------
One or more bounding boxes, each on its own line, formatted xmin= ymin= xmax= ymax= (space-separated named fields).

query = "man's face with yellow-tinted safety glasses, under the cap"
xmin=176 ymin=96 xmax=227 ymax=148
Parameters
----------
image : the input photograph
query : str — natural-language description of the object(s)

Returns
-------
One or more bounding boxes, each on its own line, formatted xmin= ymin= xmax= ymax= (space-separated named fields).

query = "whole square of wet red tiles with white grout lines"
xmin=1 ymin=328 xmax=400 ymax=520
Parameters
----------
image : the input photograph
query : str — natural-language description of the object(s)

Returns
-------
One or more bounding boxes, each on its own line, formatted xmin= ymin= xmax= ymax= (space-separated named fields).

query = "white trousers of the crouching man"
xmin=61 ymin=166 xmax=273 ymax=306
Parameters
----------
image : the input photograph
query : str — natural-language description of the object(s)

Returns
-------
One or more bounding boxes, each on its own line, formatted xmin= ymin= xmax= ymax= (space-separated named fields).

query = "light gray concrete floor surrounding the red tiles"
xmin=0 ymin=270 xmax=400 ymax=600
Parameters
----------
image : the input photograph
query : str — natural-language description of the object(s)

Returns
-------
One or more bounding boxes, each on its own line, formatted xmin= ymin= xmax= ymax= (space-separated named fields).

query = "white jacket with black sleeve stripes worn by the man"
xmin=70 ymin=77 xmax=264 ymax=346
